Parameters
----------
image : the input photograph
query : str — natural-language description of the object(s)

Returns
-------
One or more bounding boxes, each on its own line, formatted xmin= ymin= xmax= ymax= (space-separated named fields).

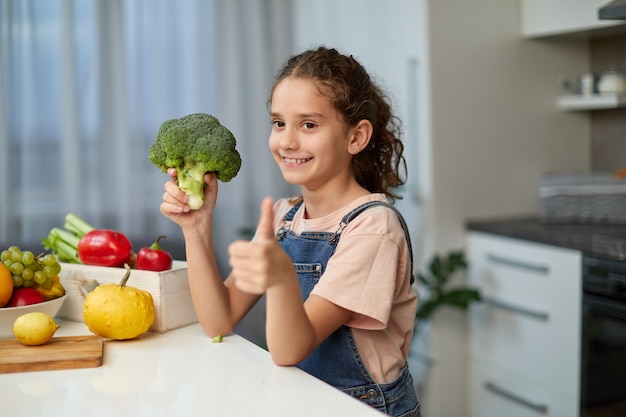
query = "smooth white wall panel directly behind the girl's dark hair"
xmin=293 ymin=0 xmax=430 ymax=263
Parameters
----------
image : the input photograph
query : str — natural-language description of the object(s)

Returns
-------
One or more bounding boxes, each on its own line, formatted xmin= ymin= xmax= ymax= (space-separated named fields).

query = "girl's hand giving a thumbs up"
xmin=228 ymin=197 xmax=296 ymax=294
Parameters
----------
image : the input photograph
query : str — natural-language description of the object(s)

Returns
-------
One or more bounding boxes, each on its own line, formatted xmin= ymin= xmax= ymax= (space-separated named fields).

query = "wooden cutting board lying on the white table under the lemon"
xmin=0 ymin=335 xmax=104 ymax=373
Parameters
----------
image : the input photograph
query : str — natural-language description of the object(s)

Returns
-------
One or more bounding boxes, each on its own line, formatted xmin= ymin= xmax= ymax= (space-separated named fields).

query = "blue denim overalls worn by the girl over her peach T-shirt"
xmin=276 ymin=201 xmax=421 ymax=417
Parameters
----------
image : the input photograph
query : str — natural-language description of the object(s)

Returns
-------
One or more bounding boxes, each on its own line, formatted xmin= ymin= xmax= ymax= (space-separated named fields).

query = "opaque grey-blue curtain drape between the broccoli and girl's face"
xmin=214 ymin=0 xmax=296 ymax=272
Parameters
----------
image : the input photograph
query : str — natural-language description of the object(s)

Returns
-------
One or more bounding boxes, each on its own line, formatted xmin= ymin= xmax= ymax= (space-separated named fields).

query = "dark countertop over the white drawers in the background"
xmin=466 ymin=216 xmax=626 ymax=260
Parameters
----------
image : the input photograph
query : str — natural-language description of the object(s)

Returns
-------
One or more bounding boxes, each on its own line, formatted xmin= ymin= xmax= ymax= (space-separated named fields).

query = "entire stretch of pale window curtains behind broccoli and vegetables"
xmin=0 ymin=0 xmax=292 ymax=272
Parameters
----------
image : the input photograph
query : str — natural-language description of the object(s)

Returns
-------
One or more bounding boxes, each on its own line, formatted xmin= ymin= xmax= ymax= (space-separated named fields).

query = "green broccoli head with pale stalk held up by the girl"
xmin=150 ymin=113 xmax=241 ymax=210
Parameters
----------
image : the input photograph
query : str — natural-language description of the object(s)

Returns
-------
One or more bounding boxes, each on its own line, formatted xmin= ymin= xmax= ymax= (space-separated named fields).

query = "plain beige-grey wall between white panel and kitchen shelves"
xmin=424 ymin=0 xmax=590 ymax=417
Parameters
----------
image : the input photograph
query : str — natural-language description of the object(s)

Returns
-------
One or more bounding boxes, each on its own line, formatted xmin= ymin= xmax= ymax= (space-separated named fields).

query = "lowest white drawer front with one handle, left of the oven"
xmin=468 ymin=362 xmax=578 ymax=417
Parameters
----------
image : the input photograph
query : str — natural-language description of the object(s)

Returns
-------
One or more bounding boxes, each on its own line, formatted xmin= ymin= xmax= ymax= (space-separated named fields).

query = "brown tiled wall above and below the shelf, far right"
xmin=591 ymin=34 xmax=626 ymax=172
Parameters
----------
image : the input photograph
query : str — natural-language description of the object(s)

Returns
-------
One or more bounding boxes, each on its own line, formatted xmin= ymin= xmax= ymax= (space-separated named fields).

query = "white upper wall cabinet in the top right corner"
xmin=520 ymin=0 xmax=624 ymax=38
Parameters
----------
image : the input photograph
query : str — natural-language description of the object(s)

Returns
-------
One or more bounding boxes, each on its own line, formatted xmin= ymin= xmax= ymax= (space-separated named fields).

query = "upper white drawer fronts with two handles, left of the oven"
xmin=468 ymin=233 xmax=581 ymax=396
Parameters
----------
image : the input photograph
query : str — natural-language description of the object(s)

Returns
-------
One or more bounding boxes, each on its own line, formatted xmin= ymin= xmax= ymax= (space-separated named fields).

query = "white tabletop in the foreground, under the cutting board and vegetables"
xmin=0 ymin=320 xmax=382 ymax=417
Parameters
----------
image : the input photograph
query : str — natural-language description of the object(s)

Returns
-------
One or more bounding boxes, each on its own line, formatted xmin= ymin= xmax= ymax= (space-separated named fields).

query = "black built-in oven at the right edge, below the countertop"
xmin=580 ymin=256 xmax=626 ymax=417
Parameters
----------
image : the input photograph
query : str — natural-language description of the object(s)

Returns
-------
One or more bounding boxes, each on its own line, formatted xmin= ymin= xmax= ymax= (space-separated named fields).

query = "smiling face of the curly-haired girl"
xmin=269 ymin=78 xmax=352 ymax=191
